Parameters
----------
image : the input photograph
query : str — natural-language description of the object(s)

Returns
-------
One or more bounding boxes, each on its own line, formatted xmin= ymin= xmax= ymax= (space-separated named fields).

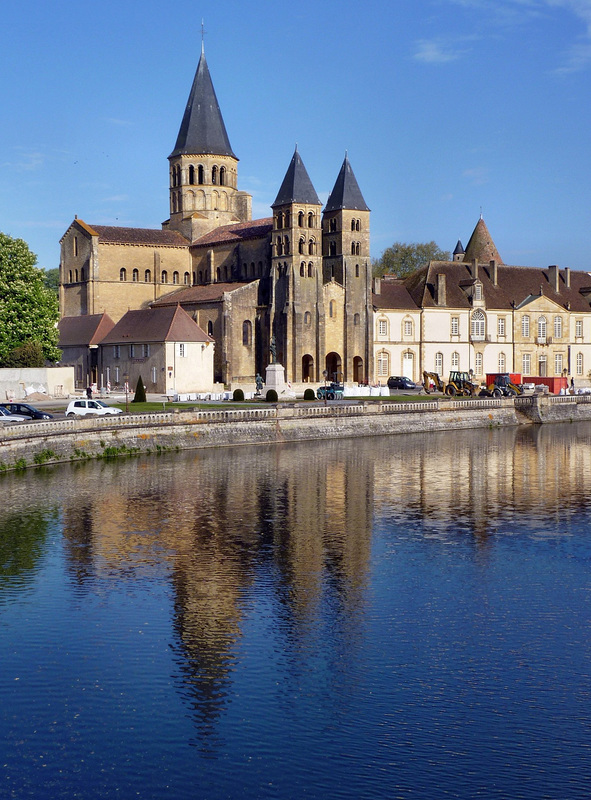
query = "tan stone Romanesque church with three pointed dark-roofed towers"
xmin=60 ymin=45 xmax=373 ymax=384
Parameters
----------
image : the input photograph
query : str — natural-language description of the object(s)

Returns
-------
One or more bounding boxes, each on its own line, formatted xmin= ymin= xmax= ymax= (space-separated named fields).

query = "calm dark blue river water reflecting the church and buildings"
xmin=0 ymin=425 xmax=591 ymax=800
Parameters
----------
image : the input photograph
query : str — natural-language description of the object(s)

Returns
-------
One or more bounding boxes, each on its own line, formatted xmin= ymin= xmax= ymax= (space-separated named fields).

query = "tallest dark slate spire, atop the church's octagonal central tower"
xmin=170 ymin=45 xmax=238 ymax=160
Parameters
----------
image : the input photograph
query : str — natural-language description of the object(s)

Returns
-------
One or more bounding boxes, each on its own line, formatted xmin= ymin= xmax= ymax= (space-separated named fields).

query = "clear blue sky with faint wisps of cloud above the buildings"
xmin=0 ymin=0 xmax=591 ymax=270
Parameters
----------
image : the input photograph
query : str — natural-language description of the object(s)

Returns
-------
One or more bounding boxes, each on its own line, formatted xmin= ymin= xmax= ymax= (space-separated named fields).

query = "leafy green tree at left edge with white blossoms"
xmin=0 ymin=233 xmax=61 ymax=367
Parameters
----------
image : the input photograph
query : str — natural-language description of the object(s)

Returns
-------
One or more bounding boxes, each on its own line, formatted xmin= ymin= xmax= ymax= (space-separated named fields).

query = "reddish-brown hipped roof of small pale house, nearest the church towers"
xmin=101 ymin=305 xmax=213 ymax=344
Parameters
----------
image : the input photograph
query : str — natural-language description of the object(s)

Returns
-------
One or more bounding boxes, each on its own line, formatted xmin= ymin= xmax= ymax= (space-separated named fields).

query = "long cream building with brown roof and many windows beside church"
xmin=374 ymin=217 xmax=591 ymax=383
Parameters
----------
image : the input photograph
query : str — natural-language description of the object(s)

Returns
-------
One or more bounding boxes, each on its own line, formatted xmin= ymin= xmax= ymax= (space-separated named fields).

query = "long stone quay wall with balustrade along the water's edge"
xmin=0 ymin=395 xmax=591 ymax=472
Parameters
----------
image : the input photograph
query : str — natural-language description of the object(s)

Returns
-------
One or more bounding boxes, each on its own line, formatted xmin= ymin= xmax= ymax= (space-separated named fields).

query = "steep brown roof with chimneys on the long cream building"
xmin=404 ymin=261 xmax=591 ymax=312
